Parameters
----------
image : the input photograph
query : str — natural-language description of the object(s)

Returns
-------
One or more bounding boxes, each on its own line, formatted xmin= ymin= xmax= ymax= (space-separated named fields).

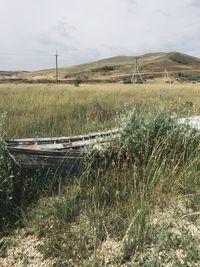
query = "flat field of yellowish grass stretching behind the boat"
xmin=0 ymin=83 xmax=200 ymax=138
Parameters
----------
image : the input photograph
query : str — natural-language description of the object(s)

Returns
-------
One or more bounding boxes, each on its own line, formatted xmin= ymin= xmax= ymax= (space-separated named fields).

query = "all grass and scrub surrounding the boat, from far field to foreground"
xmin=0 ymin=84 xmax=200 ymax=266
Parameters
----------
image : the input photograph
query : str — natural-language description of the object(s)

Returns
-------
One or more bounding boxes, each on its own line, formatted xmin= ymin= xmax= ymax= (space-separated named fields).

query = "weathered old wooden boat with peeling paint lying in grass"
xmin=5 ymin=129 xmax=119 ymax=174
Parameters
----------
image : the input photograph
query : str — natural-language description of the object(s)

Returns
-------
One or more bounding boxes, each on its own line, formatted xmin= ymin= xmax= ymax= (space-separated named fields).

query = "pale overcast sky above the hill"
xmin=0 ymin=0 xmax=200 ymax=70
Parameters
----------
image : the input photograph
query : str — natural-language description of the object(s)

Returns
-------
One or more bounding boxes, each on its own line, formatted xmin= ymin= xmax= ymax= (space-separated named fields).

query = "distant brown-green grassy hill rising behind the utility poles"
xmin=4 ymin=52 xmax=200 ymax=82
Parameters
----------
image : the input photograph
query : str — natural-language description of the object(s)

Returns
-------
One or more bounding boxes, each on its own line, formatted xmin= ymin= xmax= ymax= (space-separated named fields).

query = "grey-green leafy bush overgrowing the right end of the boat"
xmin=86 ymin=107 xmax=200 ymax=181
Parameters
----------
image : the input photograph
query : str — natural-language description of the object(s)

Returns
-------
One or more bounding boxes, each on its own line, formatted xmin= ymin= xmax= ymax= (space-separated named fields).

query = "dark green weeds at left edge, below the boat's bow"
xmin=0 ymin=115 xmax=60 ymax=232
